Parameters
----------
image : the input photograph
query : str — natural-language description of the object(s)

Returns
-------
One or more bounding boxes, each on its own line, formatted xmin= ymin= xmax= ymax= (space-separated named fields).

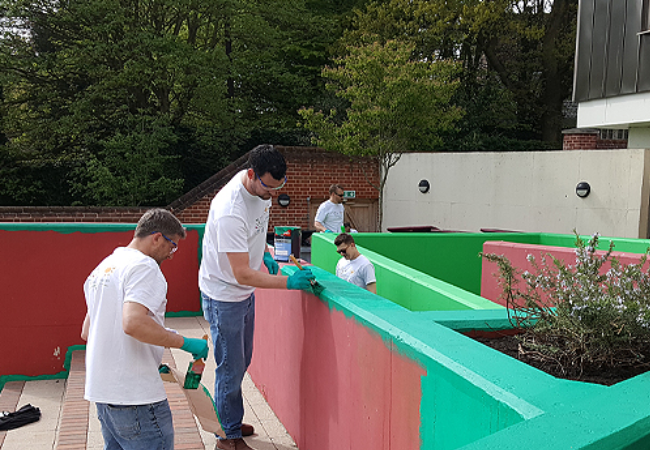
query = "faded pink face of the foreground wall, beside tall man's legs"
xmin=249 ymin=289 xmax=425 ymax=450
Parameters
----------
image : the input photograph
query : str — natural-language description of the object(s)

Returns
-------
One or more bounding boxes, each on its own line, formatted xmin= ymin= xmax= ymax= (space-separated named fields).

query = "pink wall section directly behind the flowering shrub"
xmin=481 ymin=241 xmax=642 ymax=306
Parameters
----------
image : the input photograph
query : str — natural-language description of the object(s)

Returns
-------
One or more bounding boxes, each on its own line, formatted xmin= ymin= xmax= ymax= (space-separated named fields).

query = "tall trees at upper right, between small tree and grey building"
xmin=345 ymin=0 xmax=578 ymax=145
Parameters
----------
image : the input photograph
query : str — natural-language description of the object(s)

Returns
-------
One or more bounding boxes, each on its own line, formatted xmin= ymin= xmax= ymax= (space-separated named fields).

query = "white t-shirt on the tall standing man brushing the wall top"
xmin=199 ymin=170 xmax=271 ymax=302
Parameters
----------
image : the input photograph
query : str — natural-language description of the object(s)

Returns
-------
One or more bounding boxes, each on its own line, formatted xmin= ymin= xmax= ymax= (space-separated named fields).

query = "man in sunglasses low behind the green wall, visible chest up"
xmin=334 ymin=233 xmax=377 ymax=294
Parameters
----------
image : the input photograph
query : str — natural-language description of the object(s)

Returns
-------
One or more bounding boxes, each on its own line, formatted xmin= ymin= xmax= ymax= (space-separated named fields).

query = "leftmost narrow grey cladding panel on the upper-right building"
xmin=573 ymin=0 xmax=594 ymax=102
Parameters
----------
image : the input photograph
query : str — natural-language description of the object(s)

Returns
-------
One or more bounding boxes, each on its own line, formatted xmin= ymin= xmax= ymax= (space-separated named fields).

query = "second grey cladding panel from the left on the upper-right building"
xmin=589 ymin=0 xmax=610 ymax=99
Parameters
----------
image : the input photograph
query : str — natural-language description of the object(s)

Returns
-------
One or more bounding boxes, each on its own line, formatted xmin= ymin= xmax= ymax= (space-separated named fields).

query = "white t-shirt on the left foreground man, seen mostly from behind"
xmin=84 ymin=247 xmax=167 ymax=405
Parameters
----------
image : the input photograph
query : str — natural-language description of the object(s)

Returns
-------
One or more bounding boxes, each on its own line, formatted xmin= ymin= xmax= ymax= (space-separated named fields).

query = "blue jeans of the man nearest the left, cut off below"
xmin=97 ymin=400 xmax=174 ymax=450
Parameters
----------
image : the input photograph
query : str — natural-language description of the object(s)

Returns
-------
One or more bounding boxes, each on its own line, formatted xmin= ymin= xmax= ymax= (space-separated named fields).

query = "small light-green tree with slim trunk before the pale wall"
xmin=300 ymin=41 xmax=462 ymax=229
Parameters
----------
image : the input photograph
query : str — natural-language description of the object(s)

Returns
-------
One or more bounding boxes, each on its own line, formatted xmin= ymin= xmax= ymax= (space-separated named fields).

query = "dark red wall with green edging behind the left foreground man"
xmin=0 ymin=229 xmax=201 ymax=376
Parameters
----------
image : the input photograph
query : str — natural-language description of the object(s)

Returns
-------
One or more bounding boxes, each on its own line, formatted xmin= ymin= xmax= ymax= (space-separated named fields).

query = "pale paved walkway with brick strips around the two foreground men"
xmin=0 ymin=317 xmax=297 ymax=450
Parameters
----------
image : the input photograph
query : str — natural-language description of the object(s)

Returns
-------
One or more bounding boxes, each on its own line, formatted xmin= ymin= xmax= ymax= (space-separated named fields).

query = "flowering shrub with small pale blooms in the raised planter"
xmin=481 ymin=231 xmax=650 ymax=376
